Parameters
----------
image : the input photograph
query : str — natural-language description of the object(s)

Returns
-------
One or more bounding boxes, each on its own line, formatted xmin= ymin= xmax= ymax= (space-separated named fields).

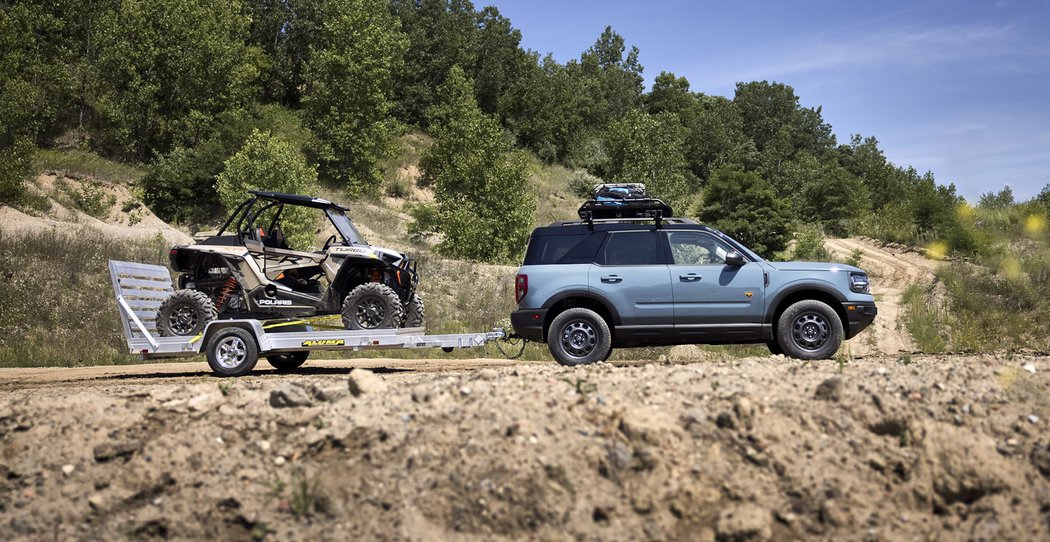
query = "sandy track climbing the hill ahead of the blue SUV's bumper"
xmin=824 ymin=238 xmax=940 ymax=356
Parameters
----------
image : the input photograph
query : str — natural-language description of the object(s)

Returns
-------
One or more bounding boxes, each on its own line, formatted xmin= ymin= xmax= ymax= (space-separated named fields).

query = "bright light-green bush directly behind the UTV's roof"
xmin=215 ymin=130 xmax=318 ymax=250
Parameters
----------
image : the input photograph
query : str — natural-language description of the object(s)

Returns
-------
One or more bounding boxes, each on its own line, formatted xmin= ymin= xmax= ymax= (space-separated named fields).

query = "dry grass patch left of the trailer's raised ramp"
xmin=0 ymin=230 xmax=169 ymax=367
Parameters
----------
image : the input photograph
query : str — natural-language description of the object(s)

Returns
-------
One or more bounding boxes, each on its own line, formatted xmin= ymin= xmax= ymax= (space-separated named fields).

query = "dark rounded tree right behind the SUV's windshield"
xmin=697 ymin=166 xmax=792 ymax=255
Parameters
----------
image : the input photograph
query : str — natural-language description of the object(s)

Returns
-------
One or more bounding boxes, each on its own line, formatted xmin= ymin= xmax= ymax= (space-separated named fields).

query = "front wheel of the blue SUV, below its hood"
xmin=777 ymin=299 xmax=843 ymax=359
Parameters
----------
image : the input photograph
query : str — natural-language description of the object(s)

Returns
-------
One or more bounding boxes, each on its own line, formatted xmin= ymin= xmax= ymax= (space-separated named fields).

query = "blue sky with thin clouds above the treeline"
xmin=485 ymin=0 xmax=1050 ymax=202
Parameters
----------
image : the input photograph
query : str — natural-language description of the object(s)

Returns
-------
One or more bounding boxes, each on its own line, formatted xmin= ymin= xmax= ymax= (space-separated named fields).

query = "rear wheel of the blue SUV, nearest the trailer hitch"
xmin=547 ymin=308 xmax=612 ymax=366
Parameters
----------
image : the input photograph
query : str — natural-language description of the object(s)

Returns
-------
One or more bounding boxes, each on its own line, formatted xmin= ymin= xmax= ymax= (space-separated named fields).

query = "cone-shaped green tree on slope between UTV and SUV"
xmin=413 ymin=67 xmax=536 ymax=262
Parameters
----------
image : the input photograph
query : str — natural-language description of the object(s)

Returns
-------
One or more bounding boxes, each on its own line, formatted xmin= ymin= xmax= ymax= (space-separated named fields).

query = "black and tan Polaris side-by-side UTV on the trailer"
xmin=156 ymin=190 xmax=423 ymax=336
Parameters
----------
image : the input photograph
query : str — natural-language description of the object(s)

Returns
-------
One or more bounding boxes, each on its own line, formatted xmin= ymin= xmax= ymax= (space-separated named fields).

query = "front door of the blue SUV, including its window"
xmin=666 ymin=230 xmax=765 ymax=340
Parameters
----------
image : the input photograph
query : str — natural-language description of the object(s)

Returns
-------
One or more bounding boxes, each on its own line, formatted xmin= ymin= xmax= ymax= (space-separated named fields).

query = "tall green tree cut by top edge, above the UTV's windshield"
xmin=302 ymin=0 xmax=407 ymax=195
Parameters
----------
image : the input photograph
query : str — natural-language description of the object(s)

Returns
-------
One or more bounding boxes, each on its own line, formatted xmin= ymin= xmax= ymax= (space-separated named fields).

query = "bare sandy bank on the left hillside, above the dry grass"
xmin=0 ymin=171 xmax=192 ymax=245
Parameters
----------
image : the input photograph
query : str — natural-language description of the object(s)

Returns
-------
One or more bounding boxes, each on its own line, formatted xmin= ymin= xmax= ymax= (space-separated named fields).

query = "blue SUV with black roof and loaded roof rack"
xmin=511 ymin=185 xmax=877 ymax=366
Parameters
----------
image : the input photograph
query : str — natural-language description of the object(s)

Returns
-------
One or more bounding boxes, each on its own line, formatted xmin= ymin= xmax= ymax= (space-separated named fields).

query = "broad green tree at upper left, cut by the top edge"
xmin=93 ymin=0 xmax=265 ymax=160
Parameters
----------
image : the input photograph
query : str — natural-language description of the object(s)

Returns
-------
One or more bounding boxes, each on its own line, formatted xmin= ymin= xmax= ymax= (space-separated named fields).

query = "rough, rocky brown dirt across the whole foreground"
xmin=0 ymin=357 xmax=1050 ymax=540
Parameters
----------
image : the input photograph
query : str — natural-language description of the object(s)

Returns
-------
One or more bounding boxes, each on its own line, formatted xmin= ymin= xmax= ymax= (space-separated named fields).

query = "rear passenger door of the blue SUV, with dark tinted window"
xmin=587 ymin=229 xmax=674 ymax=339
